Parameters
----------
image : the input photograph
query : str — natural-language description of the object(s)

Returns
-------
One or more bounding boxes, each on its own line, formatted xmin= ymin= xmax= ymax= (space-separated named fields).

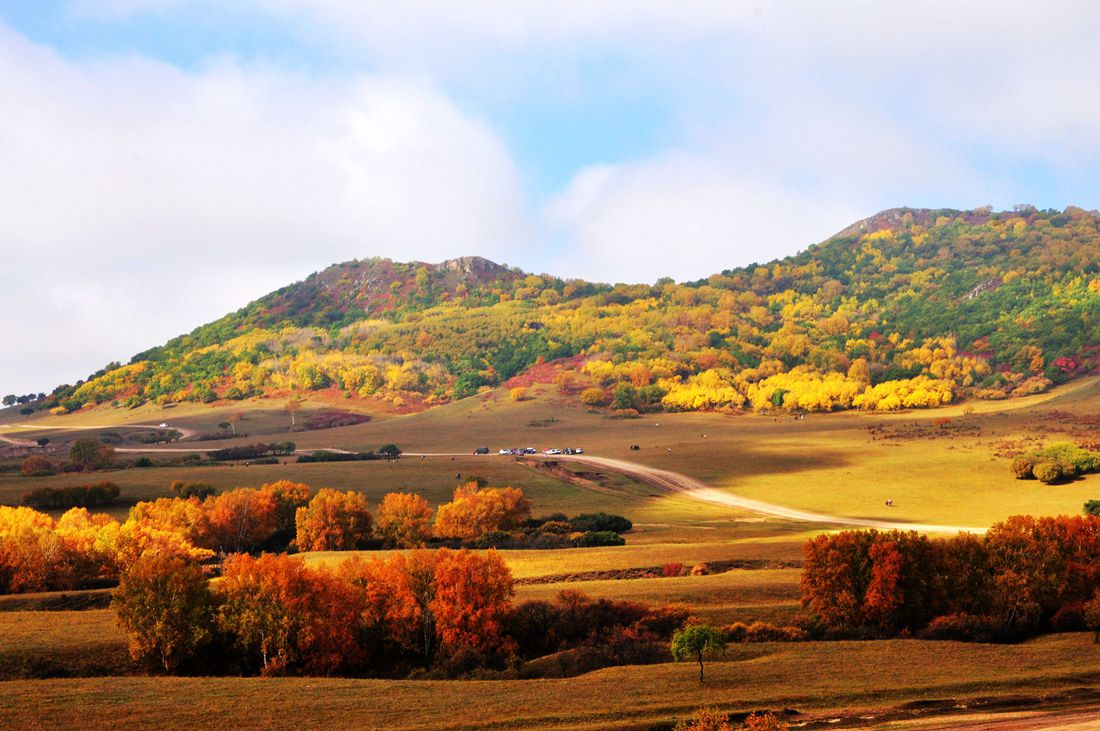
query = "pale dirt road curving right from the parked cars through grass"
xmin=556 ymin=455 xmax=986 ymax=533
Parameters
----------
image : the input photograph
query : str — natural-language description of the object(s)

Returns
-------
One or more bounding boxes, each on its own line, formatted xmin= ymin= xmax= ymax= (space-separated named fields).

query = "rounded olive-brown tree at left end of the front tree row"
xmin=111 ymin=552 xmax=215 ymax=672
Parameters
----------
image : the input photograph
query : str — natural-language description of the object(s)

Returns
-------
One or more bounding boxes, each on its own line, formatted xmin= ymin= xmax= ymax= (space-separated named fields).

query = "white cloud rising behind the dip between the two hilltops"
xmin=546 ymin=153 xmax=855 ymax=283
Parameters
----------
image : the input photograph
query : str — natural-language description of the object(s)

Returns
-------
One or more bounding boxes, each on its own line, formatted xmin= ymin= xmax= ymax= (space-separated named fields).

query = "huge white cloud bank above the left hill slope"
xmin=0 ymin=26 xmax=529 ymax=392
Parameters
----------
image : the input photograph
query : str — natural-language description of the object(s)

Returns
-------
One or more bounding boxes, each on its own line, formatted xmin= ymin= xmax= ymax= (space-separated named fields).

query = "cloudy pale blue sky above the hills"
xmin=0 ymin=0 xmax=1100 ymax=394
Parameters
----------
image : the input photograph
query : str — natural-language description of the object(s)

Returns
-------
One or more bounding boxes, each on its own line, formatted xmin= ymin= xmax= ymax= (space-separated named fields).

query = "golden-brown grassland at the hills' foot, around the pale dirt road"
xmin=8 ymin=378 xmax=1100 ymax=525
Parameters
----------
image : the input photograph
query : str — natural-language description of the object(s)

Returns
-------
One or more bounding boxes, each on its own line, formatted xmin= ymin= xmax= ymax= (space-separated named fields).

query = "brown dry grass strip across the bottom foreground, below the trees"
xmin=0 ymin=634 xmax=1100 ymax=729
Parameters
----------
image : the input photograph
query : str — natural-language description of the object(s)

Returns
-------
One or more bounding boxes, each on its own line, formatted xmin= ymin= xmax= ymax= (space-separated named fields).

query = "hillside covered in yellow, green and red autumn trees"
xmin=23 ymin=207 xmax=1100 ymax=412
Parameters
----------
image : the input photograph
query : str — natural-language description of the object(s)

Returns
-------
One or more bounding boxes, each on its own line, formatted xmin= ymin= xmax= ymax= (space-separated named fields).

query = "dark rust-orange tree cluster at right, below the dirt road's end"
xmin=801 ymin=516 xmax=1100 ymax=640
